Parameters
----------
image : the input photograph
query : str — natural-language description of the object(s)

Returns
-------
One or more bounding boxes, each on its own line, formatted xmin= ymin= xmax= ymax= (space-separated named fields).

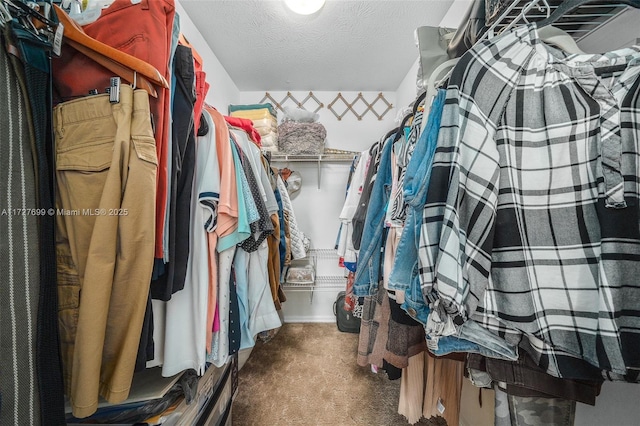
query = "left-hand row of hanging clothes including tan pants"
xmin=0 ymin=0 xmax=304 ymax=425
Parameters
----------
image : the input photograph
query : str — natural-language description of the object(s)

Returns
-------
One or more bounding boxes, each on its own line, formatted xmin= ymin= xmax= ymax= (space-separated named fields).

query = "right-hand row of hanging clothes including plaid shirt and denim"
xmin=339 ymin=5 xmax=640 ymax=424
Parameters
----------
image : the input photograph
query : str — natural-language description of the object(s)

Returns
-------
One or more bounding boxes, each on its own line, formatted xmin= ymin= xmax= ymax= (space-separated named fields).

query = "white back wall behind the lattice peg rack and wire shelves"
xmin=239 ymin=91 xmax=396 ymax=322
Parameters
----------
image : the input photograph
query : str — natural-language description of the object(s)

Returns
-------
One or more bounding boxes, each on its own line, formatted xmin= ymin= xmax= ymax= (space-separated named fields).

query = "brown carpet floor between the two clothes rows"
xmin=232 ymin=324 xmax=445 ymax=426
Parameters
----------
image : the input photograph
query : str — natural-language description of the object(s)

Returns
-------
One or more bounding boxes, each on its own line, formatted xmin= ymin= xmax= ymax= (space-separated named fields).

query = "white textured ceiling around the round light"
xmin=181 ymin=0 xmax=453 ymax=91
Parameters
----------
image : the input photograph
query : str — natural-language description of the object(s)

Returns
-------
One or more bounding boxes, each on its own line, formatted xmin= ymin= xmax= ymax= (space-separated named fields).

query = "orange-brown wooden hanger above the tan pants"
xmin=53 ymin=4 xmax=169 ymax=97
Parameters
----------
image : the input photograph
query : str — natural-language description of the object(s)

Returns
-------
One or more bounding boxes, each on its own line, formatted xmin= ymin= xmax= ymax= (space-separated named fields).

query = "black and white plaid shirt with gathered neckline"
xmin=419 ymin=24 xmax=640 ymax=378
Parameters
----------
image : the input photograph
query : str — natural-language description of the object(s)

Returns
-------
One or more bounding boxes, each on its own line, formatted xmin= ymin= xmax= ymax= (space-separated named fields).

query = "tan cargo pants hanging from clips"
xmin=54 ymin=85 xmax=157 ymax=417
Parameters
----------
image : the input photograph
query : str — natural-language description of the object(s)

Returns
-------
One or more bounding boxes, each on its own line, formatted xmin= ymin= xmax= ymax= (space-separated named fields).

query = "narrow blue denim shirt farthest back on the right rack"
xmin=353 ymin=138 xmax=393 ymax=297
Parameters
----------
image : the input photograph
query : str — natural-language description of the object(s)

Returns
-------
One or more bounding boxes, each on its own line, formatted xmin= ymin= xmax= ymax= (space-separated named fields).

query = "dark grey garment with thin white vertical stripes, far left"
xmin=0 ymin=37 xmax=40 ymax=425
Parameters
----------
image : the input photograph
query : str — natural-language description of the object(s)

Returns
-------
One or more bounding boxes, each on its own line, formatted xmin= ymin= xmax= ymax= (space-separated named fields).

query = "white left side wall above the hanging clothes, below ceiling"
xmin=176 ymin=0 xmax=240 ymax=112
